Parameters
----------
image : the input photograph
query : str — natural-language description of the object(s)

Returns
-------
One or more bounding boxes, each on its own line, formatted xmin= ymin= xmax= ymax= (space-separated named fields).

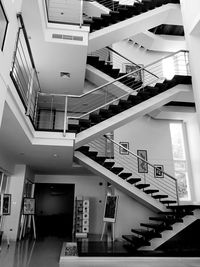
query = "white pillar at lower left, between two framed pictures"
xmin=3 ymin=165 xmax=26 ymax=241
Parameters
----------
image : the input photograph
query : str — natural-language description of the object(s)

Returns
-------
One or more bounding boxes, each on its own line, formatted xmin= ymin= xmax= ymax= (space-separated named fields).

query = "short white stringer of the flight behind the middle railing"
xmin=86 ymin=64 xmax=136 ymax=96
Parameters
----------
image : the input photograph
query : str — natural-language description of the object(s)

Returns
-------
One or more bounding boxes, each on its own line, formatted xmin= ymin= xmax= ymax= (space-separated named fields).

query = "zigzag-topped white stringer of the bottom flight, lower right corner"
xmin=138 ymin=209 xmax=200 ymax=250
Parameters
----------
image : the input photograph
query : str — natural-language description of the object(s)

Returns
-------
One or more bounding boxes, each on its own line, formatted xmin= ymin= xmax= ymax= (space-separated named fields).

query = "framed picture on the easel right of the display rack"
xmin=103 ymin=196 xmax=119 ymax=222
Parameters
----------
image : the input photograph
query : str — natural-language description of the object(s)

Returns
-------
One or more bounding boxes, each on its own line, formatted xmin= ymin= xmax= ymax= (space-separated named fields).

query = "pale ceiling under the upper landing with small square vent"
xmin=22 ymin=0 xmax=87 ymax=94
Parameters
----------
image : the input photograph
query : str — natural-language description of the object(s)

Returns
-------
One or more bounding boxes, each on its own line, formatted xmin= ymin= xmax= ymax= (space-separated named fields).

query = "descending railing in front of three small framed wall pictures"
xmin=88 ymin=135 xmax=179 ymax=205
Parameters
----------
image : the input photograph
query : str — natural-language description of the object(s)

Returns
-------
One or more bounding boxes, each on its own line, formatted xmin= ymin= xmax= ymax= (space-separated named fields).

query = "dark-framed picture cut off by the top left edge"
xmin=0 ymin=0 xmax=8 ymax=51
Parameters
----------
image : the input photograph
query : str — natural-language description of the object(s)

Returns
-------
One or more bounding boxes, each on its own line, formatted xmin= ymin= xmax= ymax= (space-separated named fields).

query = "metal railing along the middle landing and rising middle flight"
xmin=35 ymin=50 xmax=190 ymax=135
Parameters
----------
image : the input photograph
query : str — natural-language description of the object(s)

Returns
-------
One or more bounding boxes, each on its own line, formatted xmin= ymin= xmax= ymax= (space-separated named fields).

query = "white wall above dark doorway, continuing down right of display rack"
xmin=35 ymin=175 xmax=106 ymax=234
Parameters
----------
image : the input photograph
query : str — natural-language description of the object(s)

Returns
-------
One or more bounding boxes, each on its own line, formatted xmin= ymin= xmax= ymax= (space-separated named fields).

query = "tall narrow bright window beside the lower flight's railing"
xmin=170 ymin=123 xmax=191 ymax=201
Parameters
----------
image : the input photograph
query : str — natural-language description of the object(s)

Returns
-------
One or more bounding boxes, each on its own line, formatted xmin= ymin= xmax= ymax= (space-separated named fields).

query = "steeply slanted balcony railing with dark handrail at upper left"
xmin=10 ymin=13 xmax=41 ymax=127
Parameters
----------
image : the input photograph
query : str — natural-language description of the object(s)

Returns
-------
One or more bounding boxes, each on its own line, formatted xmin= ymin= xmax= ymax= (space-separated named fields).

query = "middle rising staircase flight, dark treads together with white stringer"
xmin=74 ymin=75 xmax=191 ymax=148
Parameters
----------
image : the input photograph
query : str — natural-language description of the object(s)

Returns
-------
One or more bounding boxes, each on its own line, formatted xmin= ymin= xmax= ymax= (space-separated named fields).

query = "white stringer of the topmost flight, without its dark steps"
xmin=88 ymin=4 xmax=180 ymax=53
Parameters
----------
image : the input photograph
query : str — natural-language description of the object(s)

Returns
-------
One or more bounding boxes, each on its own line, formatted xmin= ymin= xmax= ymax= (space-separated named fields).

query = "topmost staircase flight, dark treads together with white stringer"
xmin=84 ymin=0 xmax=180 ymax=52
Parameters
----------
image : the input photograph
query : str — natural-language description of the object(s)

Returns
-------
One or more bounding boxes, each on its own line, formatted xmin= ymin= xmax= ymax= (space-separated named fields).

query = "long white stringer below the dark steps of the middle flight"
xmin=75 ymin=84 xmax=192 ymax=149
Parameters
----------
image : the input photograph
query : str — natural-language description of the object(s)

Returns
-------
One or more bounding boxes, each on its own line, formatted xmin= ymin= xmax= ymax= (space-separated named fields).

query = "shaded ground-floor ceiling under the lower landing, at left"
xmin=0 ymin=103 xmax=93 ymax=174
